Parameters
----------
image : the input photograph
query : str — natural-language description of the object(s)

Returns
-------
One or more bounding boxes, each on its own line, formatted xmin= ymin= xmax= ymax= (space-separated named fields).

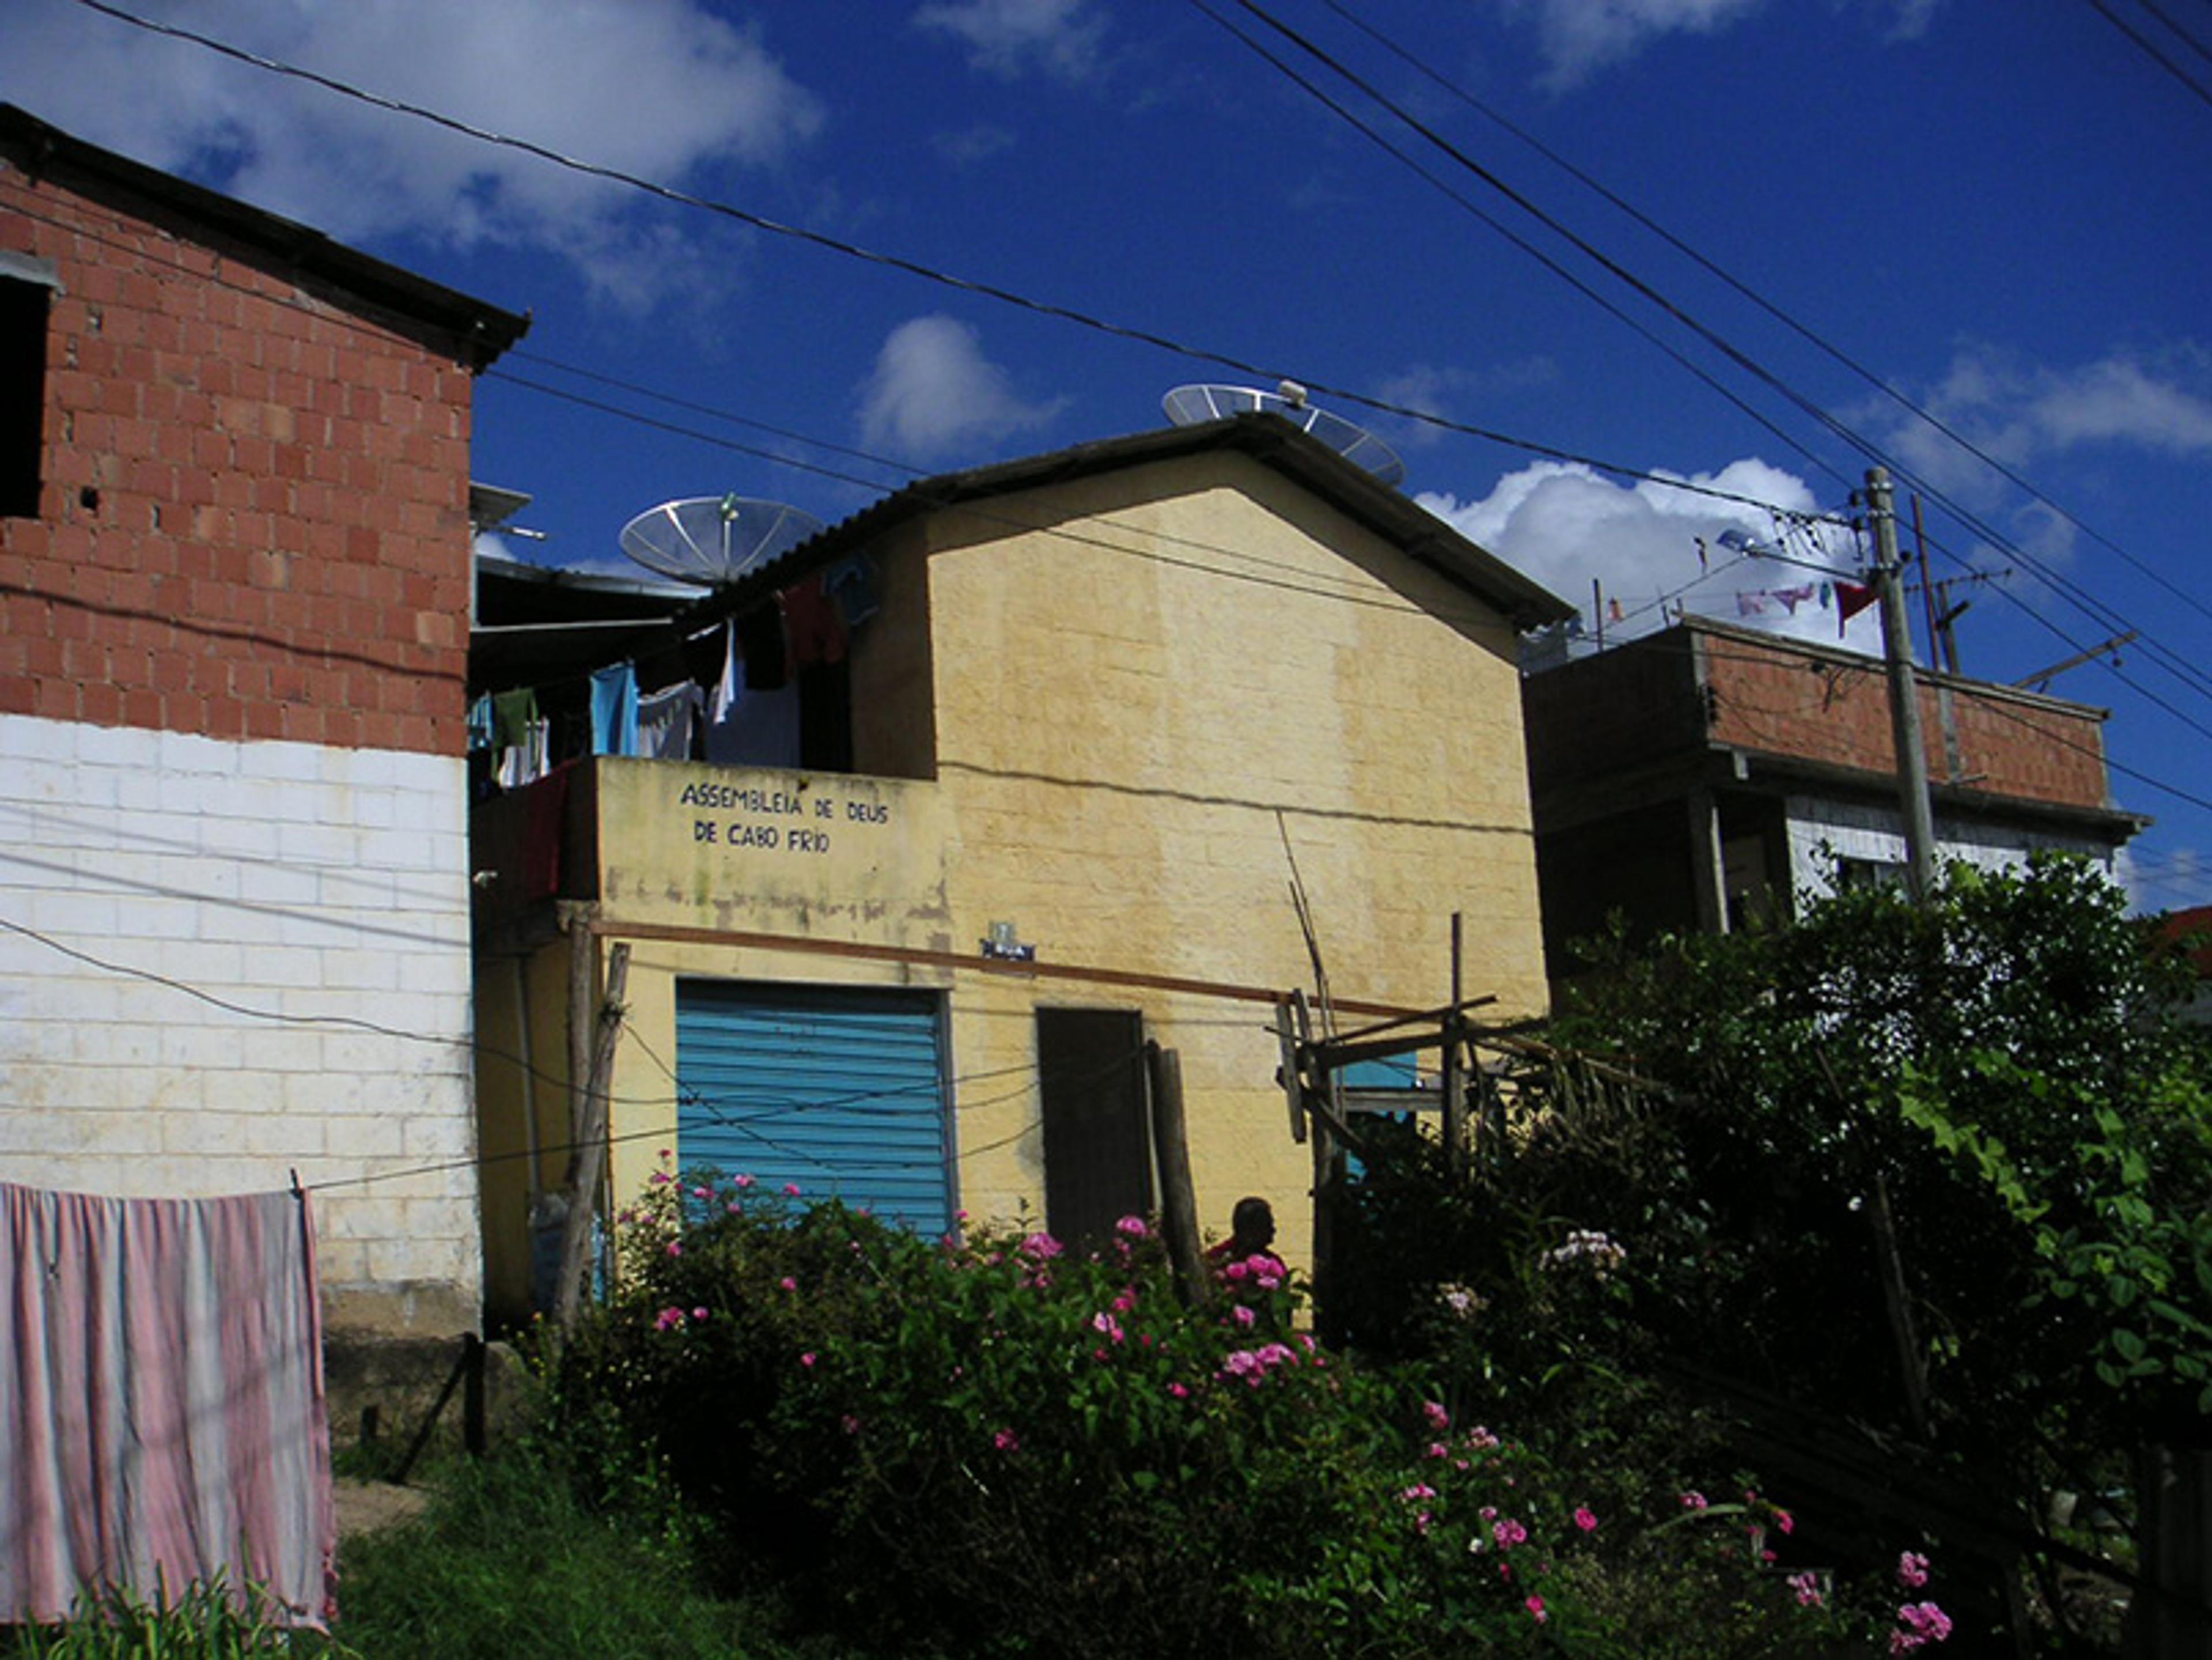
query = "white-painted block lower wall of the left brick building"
xmin=0 ymin=716 xmax=482 ymax=1335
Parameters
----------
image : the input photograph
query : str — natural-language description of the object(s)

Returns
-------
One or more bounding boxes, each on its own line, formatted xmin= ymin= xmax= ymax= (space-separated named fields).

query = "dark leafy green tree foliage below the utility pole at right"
xmin=1340 ymin=860 xmax=2212 ymax=1653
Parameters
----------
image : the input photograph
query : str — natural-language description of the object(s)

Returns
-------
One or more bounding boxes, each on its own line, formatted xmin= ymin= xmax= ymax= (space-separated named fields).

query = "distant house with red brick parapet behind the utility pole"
xmin=1522 ymin=617 xmax=2146 ymax=977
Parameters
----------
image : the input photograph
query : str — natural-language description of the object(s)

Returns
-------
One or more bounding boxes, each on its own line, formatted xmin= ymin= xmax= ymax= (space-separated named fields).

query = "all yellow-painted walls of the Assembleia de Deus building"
xmin=489 ymin=444 xmax=1544 ymax=1326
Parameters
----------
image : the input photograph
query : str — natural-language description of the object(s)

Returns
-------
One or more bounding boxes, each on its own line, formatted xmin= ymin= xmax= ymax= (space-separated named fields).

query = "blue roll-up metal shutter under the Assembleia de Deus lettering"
xmin=677 ymin=979 xmax=953 ymax=1233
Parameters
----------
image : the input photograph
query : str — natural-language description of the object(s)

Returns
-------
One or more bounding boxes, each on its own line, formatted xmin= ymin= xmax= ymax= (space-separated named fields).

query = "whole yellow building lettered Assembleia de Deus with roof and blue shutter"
xmin=476 ymin=415 xmax=1569 ymax=1317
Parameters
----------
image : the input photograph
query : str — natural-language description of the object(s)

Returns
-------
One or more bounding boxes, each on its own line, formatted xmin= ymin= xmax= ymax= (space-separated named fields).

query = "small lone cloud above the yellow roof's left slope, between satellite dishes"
xmin=861 ymin=316 xmax=1062 ymax=462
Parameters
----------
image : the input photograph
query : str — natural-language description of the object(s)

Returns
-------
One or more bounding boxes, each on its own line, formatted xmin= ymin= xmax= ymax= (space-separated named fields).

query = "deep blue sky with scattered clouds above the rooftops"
xmin=0 ymin=0 xmax=2212 ymax=906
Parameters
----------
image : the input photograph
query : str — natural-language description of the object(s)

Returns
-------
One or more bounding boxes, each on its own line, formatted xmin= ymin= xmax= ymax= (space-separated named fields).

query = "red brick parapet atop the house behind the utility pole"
xmin=1703 ymin=634 xmax=2110 ymax=807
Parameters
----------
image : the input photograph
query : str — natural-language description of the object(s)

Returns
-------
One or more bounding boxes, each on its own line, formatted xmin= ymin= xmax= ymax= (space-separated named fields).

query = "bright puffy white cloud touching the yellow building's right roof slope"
xmin=1416 ymin=460 xmax=1880 ymax=652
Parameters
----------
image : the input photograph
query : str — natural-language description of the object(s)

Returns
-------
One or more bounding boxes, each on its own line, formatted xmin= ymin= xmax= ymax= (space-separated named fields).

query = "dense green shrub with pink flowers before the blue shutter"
xmin=564 ymin=1174 xmax=1884 ymax=1658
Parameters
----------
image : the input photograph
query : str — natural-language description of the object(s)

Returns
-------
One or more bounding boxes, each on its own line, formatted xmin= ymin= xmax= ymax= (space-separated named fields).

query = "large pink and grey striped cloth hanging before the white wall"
xmin=0 ymin=1183 xmax=339 ymax=1629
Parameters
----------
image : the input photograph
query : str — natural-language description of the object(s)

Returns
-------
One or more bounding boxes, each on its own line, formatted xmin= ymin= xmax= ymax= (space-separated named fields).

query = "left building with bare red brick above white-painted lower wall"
xmin=0 ymin=108 xmax=527 ymax=1331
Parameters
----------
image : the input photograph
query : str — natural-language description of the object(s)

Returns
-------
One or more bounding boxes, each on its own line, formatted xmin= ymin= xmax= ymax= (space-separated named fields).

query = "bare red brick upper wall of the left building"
xmin=0 ymin=164 xmax=474 ymax=754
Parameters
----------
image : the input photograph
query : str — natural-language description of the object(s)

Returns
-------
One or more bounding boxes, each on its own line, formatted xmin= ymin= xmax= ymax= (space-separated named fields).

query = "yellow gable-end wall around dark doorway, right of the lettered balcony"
xmin=929 ymin=456 xmax=1544 ymax=1260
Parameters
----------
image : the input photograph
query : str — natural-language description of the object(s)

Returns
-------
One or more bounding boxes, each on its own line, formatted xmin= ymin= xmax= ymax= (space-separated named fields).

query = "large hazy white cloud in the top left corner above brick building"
xmin=0 ymin=0 xmax=821 ymax=305
